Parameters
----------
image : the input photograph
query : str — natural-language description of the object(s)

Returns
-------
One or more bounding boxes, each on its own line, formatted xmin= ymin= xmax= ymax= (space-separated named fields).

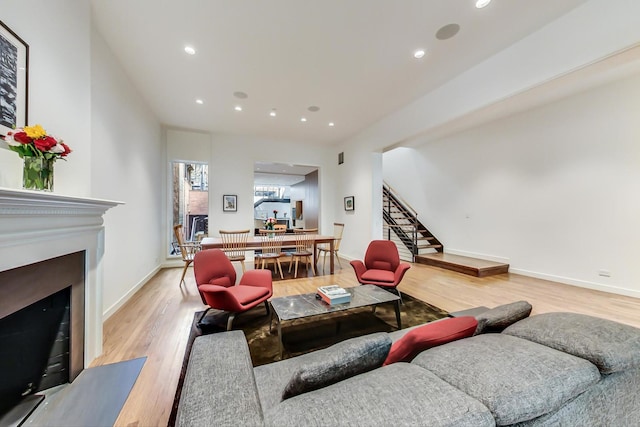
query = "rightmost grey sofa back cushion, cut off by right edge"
xmin=504 ymin=313 xmax=640 ymax=374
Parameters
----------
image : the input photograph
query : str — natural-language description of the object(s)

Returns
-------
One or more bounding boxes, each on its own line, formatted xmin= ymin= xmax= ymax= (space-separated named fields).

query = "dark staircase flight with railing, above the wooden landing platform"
xmin=382 ymin=183 xmax=444 ymax=262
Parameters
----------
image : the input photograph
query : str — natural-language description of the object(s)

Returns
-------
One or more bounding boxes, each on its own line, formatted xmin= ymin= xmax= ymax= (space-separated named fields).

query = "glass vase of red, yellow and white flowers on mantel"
xmin=5 ymin=125 xmax=71 ymax=191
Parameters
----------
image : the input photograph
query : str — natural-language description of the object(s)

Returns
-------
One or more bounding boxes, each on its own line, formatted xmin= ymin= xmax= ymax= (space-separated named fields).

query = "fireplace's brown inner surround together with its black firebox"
xmin=0 ymin=252 xmax=85 ymax=424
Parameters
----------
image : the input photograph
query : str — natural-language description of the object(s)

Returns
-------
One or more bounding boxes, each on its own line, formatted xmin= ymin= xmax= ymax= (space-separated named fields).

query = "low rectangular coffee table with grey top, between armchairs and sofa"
xmin=270 ymin=285 xmax=402 ymax=359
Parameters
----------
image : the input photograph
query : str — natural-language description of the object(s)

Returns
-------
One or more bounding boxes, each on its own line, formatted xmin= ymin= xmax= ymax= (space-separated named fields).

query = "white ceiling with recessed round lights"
xmin=91 ymin=0 xmax=584 ymax=144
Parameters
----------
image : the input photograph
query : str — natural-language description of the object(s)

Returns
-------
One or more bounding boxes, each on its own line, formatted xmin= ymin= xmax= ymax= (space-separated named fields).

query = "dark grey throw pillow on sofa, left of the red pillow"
xmin=282 ymin=332 xmax=391 ymax=400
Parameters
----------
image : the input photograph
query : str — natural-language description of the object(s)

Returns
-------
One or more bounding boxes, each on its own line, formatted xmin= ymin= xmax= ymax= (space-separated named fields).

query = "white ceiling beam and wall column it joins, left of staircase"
xmin=334 ymin=0 xmax=640 ymax=282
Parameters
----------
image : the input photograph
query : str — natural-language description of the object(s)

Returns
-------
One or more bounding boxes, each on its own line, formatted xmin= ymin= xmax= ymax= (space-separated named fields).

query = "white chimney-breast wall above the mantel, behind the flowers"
xmin=0 ymin=0 xmax=92 ymax=196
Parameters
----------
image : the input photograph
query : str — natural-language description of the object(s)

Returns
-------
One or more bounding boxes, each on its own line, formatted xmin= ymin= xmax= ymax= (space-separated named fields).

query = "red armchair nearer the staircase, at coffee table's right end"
xmin=351 ymin=240 xmax=411 ymax=296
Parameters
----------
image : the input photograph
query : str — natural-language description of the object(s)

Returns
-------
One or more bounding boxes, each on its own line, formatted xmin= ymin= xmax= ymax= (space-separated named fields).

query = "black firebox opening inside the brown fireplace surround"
xmin=0 ymin=287 xmax=71 ymax=414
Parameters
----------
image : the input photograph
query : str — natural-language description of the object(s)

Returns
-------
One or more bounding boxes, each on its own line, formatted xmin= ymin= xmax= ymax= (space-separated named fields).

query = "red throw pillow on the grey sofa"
xmin=384 ymin=316 xmax=478 ymax=365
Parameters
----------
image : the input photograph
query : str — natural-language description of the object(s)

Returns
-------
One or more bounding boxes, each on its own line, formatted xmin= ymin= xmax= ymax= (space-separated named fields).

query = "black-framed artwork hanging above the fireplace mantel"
xmin=0 ymin=21 xmax=29 ymax=136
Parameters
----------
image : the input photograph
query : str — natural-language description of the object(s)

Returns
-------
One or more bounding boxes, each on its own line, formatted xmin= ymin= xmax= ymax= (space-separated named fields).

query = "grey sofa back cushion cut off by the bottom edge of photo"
xmin=265 ymin=363 xmax=495 ymax=427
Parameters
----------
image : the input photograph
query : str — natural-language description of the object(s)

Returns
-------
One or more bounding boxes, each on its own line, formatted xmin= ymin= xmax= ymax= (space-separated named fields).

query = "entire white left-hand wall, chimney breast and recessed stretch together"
xmin=0 ymin=0 xmax=163 ymax=316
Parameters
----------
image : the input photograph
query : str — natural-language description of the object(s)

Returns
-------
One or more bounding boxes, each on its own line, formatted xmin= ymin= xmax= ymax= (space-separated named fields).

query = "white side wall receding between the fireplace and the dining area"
xmin=91 ymin=24 xmax=165 ymax=317
